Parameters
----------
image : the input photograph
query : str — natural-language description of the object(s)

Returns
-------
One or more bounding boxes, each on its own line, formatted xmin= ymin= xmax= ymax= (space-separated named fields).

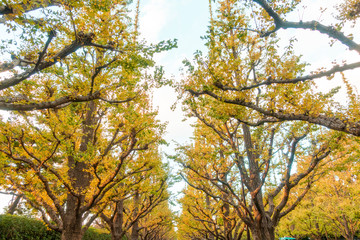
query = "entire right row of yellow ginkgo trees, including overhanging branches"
xmin=174 ymin=0 xmax=360 ymax=240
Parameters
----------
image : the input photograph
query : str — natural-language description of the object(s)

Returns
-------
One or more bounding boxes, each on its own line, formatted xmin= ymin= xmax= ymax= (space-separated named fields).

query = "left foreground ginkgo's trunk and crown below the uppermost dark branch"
xmin=0 ymin=25 xmax=163 ymax=239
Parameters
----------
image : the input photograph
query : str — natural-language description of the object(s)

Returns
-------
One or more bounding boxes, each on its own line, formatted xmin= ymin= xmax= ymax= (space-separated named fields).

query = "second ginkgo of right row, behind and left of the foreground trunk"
xmin=179 ymin=125 xmax=245 ymax=240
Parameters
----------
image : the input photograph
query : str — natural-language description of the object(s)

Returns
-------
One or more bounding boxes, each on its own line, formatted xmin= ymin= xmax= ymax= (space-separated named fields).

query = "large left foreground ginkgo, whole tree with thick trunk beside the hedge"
xmin=0 ymin=1 xmax=171 ymax=236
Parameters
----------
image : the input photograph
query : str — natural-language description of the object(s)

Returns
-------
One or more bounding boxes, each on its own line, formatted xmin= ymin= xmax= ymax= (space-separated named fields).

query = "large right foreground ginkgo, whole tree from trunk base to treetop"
xmin=179 ymin=0 xmax=343 ymax=239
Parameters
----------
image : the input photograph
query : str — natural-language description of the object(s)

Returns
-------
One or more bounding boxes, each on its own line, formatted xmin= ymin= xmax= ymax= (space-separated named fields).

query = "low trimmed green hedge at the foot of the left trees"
xmin=0 ymin=215 xmax=111 ymax=240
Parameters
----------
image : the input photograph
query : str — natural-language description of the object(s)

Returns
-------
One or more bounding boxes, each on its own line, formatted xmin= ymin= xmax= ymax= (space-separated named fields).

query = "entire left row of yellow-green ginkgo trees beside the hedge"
xmin=0 ymin=0 xmax=176 ymax=240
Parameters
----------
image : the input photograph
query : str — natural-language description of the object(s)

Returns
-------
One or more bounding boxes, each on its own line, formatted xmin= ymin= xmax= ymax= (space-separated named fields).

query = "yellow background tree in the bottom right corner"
xmin=279 ymin=146 xmax=360 ymax=239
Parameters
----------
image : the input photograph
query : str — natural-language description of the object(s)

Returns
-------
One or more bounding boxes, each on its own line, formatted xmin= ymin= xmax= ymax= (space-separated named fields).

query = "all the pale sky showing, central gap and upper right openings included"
xmin=0 ymin=0 xmax=360 ymax=212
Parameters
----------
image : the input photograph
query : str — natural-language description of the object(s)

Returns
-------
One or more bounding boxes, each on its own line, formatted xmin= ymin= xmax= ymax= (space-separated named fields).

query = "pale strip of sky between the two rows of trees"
xmin=139 ymin=0 xmax=210 ymax=211
